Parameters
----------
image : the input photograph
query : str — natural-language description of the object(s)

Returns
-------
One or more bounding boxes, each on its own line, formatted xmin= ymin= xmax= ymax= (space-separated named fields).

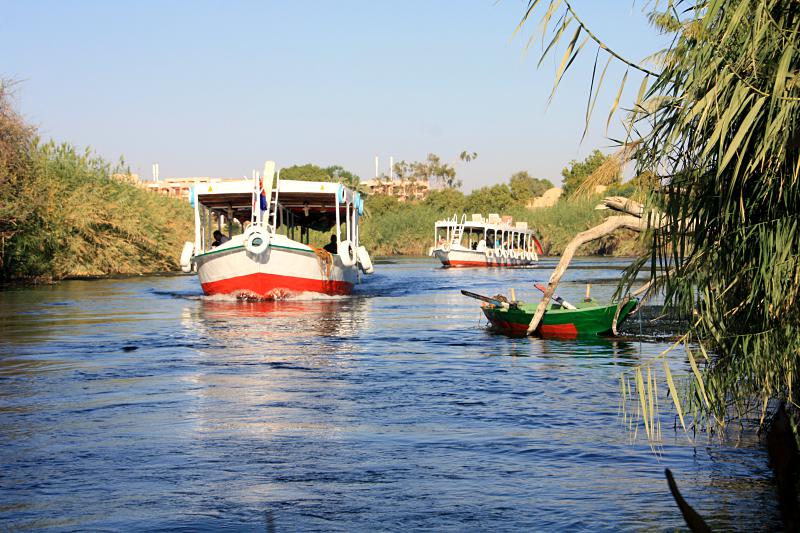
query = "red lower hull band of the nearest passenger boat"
xmin=203 ymin=273 xmax=353 ymax=298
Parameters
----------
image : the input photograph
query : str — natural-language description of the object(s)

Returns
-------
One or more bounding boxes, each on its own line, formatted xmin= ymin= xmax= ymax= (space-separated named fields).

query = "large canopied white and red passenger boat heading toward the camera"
xmin=181 ymin=161 xmax=373 ymax=299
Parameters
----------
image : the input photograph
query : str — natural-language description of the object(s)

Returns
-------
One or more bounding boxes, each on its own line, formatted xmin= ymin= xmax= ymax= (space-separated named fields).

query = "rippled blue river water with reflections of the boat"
xmin=0 ymin=259 xmax=780 ymax=532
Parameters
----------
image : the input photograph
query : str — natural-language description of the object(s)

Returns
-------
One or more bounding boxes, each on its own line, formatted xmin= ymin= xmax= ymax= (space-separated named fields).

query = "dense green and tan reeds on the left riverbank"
xmin=0 ymin=83 xmax=193 ymax=281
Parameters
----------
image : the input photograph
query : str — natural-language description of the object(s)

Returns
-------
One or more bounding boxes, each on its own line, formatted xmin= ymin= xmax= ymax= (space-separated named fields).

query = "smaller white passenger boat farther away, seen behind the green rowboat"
xmin=430 ymin=213 xmax=542 ymax=267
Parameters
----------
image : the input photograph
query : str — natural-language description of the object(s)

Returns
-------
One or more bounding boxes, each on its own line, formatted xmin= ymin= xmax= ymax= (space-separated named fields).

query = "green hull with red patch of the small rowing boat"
xmin=483 ymin=299 xmax=638 ymax=339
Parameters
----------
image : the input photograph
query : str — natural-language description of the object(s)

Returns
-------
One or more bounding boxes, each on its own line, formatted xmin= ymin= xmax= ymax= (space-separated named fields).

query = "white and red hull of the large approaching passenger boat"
xmin=195 ymin=242 xmax=358 ymax=300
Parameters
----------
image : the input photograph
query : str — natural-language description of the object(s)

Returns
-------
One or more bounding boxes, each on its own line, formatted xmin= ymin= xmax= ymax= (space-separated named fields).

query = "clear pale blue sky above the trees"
xmin=0 ymin=0 xmax=666 ymax=190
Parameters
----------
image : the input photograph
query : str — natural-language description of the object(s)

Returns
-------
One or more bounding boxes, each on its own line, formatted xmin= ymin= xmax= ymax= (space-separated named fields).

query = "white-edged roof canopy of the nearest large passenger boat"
xmin=193 ymin=180 xmax=364 ymax=231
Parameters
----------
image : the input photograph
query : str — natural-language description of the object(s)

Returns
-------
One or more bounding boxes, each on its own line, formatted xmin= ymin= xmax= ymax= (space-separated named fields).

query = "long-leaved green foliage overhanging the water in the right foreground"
xmin=523 ymin=0 xmax=800 ymax=434
